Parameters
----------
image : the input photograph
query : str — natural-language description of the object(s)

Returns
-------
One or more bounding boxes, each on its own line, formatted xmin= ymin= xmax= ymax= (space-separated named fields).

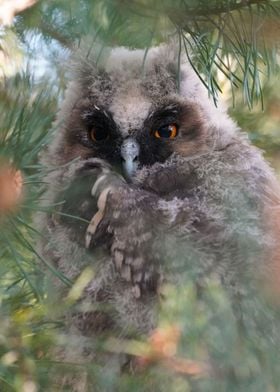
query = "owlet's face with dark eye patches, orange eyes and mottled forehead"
xmin=55 ymin=47 xmax=211 ymax=178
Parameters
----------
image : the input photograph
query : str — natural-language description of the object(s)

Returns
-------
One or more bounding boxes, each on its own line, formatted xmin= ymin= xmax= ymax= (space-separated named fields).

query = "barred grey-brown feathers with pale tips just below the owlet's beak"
xmin=85 ymin=169 xmax=162 ymax=299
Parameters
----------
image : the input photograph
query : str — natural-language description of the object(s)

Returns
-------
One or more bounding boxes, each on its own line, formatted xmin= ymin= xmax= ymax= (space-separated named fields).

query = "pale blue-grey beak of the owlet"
xmin=121 ymin=137 xmax=140 ymax=177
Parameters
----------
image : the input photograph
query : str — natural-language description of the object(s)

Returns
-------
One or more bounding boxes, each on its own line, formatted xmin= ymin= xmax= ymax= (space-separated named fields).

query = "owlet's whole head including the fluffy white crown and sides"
xmin=51 ymin=46 xmax=236 ymax=177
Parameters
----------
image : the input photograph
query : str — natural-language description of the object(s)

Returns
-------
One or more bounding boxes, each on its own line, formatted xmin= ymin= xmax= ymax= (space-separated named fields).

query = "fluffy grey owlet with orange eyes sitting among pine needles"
xmin=40 ymin=45 xmax=280 ymax=382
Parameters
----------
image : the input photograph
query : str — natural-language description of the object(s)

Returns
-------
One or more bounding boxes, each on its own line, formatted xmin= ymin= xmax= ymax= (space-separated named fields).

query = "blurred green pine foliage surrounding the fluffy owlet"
xmin=0 ymin=0 xmax=280 ymax=392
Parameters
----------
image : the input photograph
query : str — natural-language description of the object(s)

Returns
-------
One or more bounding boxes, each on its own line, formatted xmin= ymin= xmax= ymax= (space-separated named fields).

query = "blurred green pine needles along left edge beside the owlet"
xmin=0 ymin=75 xmax=56 ymax=392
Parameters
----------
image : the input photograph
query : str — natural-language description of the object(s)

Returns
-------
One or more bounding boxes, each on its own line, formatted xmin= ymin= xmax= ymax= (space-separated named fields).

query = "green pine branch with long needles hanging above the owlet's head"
xmin=16 ymin=0 xmax=280 ymax=107
